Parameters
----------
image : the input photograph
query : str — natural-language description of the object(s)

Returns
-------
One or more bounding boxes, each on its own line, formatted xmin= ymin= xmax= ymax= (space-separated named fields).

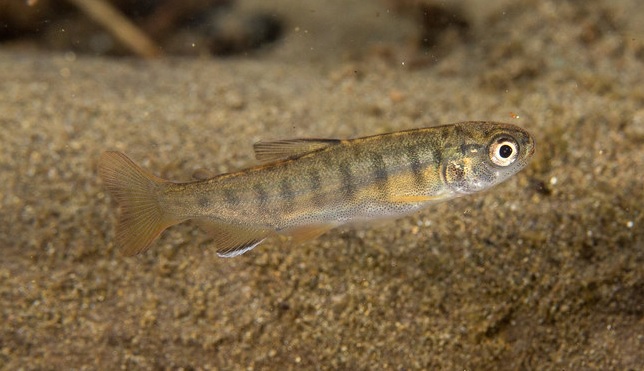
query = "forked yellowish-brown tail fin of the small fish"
xmin=98 ymin=152 xmax=179 ymax=255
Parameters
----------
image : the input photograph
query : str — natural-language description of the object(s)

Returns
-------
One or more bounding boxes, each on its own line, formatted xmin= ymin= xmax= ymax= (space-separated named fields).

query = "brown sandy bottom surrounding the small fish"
xmin=0 ymin=0 xmax=644 ymax=370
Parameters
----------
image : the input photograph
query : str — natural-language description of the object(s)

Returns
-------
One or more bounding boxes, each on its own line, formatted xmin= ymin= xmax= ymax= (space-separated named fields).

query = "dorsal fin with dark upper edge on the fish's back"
xmin=253 ymin=139 xmax=341 ymax=162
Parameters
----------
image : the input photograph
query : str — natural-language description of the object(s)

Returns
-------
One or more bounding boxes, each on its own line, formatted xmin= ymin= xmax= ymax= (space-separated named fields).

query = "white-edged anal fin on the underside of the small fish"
xmin=196 ymin=218 xmax=273 ymax=258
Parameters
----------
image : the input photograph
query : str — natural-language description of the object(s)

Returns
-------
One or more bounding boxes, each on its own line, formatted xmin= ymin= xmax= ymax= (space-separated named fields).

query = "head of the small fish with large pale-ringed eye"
xmin=441 ymin=122 xmax=535 ymax=195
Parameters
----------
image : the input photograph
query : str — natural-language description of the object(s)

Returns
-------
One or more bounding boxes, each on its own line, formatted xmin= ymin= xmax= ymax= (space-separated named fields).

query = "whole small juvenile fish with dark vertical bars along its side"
xmin=98 ymin=122 xmax=534 ymax=257
